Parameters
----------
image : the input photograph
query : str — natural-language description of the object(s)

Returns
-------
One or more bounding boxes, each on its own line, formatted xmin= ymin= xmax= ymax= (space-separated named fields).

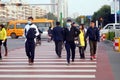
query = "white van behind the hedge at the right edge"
xmin=100 ymin=23 xmax=120 ymax=36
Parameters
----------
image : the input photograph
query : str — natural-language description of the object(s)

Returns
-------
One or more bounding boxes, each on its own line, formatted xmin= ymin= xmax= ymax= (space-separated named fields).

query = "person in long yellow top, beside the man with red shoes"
xmin=78 ymin=25 xmax=86 ymax=59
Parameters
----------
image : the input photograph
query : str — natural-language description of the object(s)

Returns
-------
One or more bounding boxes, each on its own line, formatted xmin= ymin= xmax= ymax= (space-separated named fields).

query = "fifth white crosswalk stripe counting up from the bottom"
xmin=3 ymin=58 xmax=96 ymax=61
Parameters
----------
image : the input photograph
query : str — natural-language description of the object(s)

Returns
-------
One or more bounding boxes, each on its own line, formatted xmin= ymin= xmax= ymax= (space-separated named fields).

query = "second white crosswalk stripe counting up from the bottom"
xmin=0 ymin=69 xmax=96 ymax=72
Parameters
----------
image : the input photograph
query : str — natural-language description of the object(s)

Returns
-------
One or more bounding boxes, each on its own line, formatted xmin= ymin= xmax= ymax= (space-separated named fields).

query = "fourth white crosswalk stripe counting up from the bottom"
xmin=0 ymin=61 xmax=97 ymax=64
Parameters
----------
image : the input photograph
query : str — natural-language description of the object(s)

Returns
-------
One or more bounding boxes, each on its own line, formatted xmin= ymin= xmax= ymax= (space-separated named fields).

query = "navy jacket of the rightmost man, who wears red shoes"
xmin=85 ymin=27 xmax=100 ymax=41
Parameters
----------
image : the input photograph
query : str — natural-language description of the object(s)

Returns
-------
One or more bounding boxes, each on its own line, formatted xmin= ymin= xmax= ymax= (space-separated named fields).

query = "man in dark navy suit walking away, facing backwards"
xmin=52 ymin=22 xmax=63 ymax=58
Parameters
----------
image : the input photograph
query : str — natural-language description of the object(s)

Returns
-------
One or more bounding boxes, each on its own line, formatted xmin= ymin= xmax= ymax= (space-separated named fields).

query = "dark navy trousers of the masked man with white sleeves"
xmin=25 ymin=40 xmax=35 ymax=62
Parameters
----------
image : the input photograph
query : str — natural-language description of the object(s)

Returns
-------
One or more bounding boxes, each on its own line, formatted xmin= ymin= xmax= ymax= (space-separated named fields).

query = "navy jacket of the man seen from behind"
xmin=52 ymin=26 xmax=63 ymax=41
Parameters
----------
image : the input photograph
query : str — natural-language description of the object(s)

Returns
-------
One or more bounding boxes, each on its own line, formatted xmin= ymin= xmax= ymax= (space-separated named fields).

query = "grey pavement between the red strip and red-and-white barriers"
xmin=103 ymin=41 xmax=120 ymax=80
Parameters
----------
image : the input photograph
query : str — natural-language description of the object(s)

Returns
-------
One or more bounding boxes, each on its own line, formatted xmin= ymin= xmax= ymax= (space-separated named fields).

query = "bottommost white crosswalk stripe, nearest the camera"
xmin=0 ymin=75 xmax=96 ymax=79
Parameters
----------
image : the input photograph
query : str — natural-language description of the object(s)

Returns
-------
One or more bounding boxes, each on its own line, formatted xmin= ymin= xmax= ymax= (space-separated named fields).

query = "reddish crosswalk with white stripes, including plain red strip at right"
xmin=0 ymin=42 xmax=114 ymax=80
